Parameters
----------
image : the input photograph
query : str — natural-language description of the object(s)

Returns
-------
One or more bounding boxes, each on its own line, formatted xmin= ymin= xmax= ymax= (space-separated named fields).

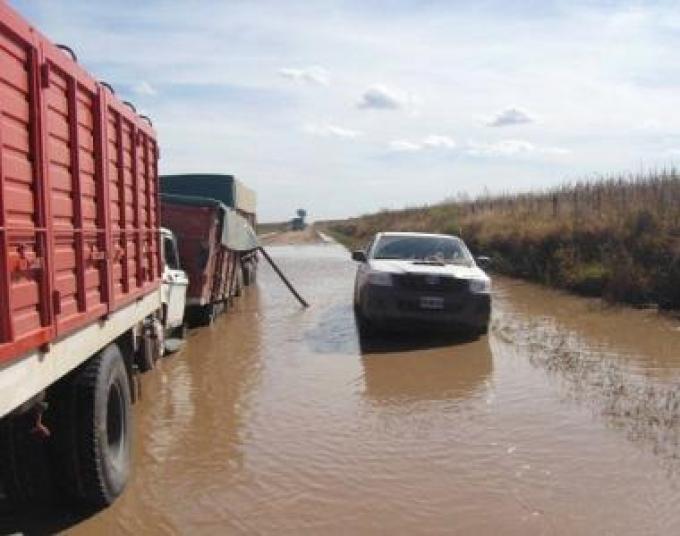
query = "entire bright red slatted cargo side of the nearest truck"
xmin=0 ymin=2 xmax=161 ymax=361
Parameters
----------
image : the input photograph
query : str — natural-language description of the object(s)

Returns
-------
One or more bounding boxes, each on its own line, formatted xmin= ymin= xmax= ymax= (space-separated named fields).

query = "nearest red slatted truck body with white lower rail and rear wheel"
xmin=0 ymin=1 xmax=169 ymax=506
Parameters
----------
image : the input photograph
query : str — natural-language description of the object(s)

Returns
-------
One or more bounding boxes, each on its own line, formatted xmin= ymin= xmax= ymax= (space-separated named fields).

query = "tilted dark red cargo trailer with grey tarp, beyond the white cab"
xmin=161 ymin=194 xmax=258 ymax=325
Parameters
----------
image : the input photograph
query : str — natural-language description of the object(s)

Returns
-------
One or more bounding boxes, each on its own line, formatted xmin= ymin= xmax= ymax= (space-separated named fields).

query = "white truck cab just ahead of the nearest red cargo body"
xmin=161 ymin=228 xmax=189 ymax=339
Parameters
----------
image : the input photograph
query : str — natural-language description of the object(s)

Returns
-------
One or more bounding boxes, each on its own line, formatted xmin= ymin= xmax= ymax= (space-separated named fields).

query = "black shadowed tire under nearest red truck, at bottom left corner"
xmin=0 ymin=413 xmax=52 ymax=508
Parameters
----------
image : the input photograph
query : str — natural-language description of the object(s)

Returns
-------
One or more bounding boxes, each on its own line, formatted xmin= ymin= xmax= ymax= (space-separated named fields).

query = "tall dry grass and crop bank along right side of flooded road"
xmin=323 ymin=170 xmax=680 ymax=309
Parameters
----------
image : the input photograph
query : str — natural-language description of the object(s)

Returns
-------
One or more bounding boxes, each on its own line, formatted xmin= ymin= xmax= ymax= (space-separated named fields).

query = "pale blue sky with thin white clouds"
xmin=9 ymin=0 xmax=680 ymax=221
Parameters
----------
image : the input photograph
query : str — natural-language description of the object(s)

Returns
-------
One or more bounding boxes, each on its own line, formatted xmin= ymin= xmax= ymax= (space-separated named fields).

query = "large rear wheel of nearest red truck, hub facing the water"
xmin=71 ymin=344 xmax=132 ymax=508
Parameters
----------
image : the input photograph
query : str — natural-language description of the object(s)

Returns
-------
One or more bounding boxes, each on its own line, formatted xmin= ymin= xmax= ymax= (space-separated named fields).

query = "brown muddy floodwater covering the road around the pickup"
xmin=1 ymin=244 xmax=680 ymax=535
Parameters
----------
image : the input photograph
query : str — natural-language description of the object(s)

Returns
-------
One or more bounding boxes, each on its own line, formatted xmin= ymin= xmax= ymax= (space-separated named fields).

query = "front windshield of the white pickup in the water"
xmin=372 ymin=235 xmax=472 ymax=265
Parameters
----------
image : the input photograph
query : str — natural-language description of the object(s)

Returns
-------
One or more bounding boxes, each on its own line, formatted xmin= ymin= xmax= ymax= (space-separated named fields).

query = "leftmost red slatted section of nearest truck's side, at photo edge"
xmin=0 ymin=17 xmax=50 ymax=357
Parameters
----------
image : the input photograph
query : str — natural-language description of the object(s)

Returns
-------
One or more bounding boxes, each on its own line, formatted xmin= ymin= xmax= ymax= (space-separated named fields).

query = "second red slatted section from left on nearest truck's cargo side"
xmin=43 ymin=56 xmax=107 ymax=332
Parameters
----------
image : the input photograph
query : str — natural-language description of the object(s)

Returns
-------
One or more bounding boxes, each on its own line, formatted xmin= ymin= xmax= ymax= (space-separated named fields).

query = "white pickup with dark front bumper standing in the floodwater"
xmin=352 ymin=232 xmax=491 ymax=335
